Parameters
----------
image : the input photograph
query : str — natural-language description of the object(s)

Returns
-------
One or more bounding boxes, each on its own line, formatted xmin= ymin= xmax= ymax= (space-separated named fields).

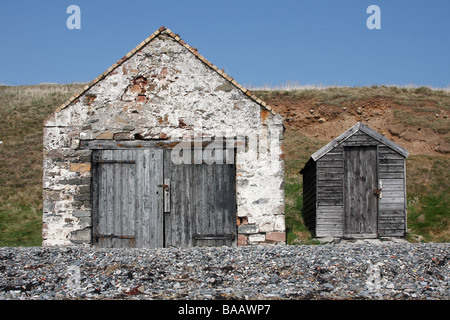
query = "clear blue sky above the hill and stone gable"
xmin=0 ymin=0 xmax=450 ymax=88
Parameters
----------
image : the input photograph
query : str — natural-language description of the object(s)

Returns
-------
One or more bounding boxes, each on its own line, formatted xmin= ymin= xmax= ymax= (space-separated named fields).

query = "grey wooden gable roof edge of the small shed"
xmin=311 ymin=122 xmax=409 ymax=161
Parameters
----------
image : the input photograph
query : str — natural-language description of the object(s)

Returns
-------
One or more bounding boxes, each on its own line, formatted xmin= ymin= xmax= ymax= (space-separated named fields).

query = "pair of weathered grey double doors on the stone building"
xmin=92 ymin=148 xmax=237 ymax=248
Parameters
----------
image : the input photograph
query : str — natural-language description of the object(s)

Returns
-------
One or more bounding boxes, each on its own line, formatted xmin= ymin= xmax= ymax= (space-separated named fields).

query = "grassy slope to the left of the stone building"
xmin=0 ymin=84 xmax=83 ymax=246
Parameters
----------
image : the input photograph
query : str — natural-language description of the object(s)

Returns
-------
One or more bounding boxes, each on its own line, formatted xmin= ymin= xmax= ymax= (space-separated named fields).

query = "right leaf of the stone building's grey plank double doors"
xmin=164 ymin=150 xmax=237 ymax=247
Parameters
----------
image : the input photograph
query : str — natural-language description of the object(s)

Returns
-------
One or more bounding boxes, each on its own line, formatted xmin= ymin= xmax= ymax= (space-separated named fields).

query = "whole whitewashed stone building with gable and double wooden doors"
xmin=43 ymin=27 xmax=285 ymax=247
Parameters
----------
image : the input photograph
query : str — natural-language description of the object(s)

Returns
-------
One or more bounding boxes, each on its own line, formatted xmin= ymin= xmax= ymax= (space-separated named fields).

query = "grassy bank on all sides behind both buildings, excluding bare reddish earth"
xmin=0 ymin=84 xmax=450 ymax=246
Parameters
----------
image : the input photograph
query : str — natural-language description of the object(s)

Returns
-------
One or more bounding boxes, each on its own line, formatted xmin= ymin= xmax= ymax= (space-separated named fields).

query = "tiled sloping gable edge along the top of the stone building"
xmin=49 ymin=26 xmax=275 ymax=114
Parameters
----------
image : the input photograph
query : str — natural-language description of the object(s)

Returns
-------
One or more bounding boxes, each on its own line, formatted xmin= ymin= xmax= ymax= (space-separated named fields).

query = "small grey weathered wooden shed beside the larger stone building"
xmin=300 ymin=122 xmax=408 ymax=239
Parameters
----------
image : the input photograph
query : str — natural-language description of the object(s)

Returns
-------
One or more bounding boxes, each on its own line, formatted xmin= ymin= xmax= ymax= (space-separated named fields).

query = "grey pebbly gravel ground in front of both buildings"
xmin=0 ymin=243 xmax=450 ymax=300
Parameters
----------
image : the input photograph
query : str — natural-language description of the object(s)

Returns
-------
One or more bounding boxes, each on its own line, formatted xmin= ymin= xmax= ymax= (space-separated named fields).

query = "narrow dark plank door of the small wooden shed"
xmin=344 ymin=146 xmax=378 ymax=238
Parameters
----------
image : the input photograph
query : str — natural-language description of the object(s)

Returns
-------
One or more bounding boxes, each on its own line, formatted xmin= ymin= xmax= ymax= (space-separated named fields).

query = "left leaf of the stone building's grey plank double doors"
xmin=92 ymin=149 xmax=164 ymax=248
